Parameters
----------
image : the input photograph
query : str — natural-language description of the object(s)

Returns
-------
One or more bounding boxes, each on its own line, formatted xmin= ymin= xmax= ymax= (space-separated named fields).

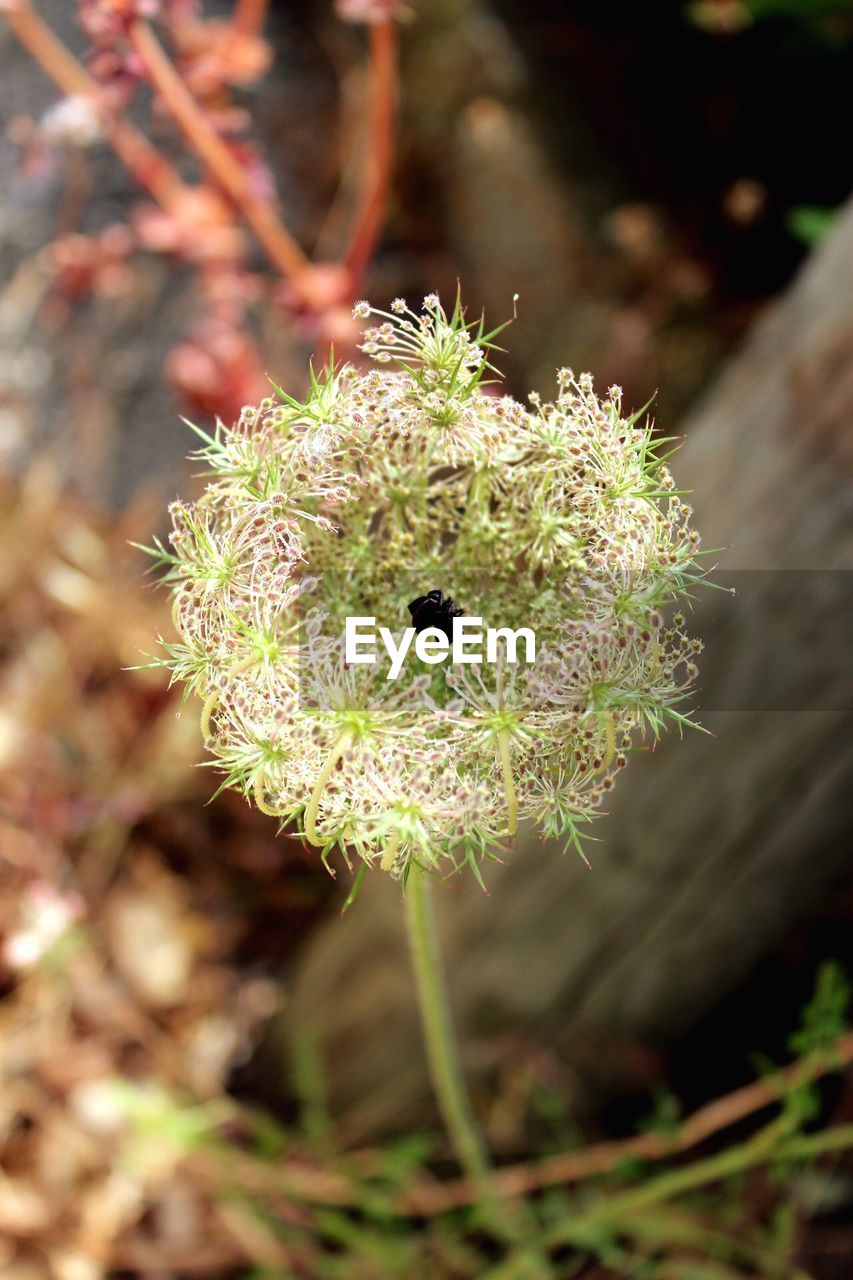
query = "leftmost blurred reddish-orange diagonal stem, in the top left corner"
xmin=0 ymin=0 xmax=187 ymax=209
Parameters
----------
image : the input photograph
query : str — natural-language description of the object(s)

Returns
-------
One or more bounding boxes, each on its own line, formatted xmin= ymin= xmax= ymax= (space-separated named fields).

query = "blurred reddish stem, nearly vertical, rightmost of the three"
xmin=345 ymin=20 xmax=397 ymax=289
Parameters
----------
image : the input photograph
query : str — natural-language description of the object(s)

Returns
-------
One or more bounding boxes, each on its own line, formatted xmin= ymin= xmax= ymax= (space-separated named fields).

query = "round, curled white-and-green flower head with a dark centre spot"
xmin=147 ymin=296 xmax=702 ymax=878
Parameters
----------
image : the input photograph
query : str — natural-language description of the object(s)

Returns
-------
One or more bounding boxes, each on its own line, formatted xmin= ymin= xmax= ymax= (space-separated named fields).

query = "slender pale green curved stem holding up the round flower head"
xmin=405 ymin=867 xmax=492 ymax=1201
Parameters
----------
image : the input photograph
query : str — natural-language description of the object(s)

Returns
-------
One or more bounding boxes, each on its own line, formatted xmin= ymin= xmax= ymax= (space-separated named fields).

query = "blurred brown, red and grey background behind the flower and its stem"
xmin=0 ymin=0 xmax=853 ymax=1280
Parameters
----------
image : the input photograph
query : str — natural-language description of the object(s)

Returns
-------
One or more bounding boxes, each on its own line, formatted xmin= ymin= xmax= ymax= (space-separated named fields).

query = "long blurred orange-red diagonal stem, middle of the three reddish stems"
xmin=131 ymin=22 xmax=318 ymax=305
